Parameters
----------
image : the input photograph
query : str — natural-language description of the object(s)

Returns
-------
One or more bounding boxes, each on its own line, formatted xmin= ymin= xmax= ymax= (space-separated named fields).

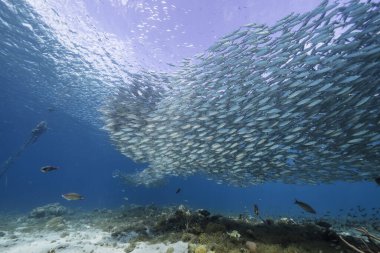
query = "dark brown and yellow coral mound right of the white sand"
xmin=142 ymin=206 xmax=343 ymax=253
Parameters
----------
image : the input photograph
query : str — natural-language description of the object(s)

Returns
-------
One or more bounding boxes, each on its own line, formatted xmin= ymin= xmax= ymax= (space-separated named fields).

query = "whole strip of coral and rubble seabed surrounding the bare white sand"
xmin=0 ymin=205 xmax=378 ymax=253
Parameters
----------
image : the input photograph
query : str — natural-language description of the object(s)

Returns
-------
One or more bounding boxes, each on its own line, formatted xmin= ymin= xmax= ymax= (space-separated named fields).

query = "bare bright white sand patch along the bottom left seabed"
xmin=0 ymin=227 xmax=187 ymax=253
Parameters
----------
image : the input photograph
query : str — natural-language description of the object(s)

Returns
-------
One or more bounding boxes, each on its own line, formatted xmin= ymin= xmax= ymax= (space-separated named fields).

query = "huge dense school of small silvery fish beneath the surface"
xmin=102 ymin=0 xmax=380 ymax=186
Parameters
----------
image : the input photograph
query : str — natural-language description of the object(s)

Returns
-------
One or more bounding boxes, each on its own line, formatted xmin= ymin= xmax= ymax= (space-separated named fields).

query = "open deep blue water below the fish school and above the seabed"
xmin=0 ymin=0 xmax=380 ymax=223
